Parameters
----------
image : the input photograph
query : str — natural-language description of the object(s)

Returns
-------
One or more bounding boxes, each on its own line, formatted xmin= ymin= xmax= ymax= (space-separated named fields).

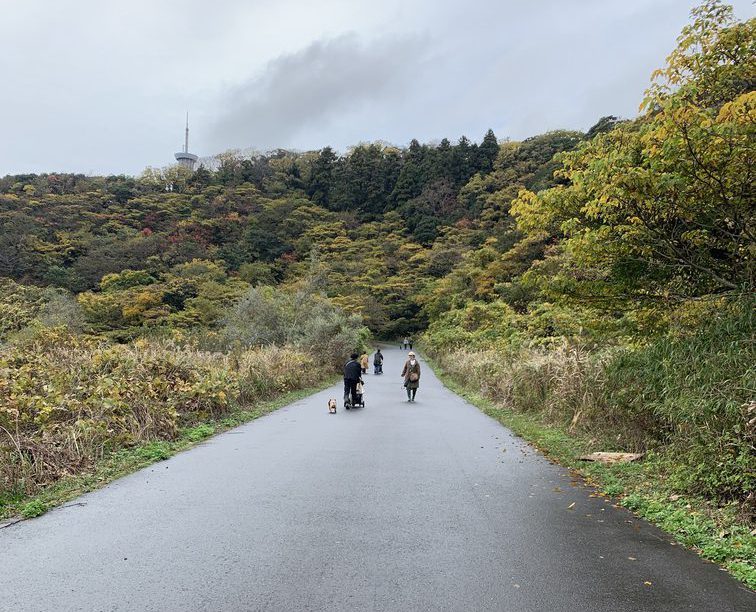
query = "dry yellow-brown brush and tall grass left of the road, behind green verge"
xmin=0 ymin=330 xmax=326 ymax=494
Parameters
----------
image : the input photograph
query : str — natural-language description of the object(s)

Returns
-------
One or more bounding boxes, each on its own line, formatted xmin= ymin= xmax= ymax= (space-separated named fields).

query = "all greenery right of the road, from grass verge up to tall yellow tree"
xmin=424 ymin=1 xmax=756 ymax=588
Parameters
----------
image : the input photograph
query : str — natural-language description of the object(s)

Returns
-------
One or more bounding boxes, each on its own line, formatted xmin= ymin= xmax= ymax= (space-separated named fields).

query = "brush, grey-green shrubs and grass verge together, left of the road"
xmin=0 ymin=282 xmax=368 ymax=518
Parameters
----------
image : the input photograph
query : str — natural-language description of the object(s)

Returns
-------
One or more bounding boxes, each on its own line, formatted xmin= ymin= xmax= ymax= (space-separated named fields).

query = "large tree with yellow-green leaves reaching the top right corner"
xmin=512 ymin=0 xmax=756 ymax=298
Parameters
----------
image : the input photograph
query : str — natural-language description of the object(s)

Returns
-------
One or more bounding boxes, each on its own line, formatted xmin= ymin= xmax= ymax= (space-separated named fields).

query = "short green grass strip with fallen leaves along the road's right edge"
xmin=426 ymin=356 xmax=756 ymax=590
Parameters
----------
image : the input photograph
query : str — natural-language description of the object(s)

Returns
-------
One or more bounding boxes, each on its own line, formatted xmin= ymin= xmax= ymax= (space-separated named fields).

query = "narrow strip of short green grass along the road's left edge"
xmin=0 ymin=378 xmax=336 ymax=528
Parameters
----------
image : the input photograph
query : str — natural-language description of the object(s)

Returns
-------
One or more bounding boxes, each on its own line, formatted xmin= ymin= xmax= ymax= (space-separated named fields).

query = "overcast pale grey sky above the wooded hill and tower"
xmin=0 ymin=0 xmax=754 ymax=176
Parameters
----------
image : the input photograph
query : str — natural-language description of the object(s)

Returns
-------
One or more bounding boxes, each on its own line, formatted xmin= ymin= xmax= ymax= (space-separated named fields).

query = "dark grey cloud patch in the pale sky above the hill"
xmin=206 ymin=35 xmax=425 ymax=150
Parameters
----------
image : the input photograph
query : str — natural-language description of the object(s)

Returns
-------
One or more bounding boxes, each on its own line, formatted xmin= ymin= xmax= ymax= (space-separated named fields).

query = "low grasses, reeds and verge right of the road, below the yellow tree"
xmin=426 ymin=303 xmax=756 ymax=590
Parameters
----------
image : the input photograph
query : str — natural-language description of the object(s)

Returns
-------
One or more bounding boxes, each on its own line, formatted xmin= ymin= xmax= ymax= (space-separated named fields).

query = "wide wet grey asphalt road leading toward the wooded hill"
xmin=0 ymin=350 xmax=756 ymax=612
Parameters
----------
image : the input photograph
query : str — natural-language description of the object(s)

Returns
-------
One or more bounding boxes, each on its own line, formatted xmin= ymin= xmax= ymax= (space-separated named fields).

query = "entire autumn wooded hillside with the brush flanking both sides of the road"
xmin=0 ymin=0 xmax=756 ymax=580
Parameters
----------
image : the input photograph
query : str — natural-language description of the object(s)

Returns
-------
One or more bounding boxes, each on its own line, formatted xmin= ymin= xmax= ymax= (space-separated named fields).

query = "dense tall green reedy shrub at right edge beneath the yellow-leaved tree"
xmin=604 ymin=300 xmax=756 ymax=503
